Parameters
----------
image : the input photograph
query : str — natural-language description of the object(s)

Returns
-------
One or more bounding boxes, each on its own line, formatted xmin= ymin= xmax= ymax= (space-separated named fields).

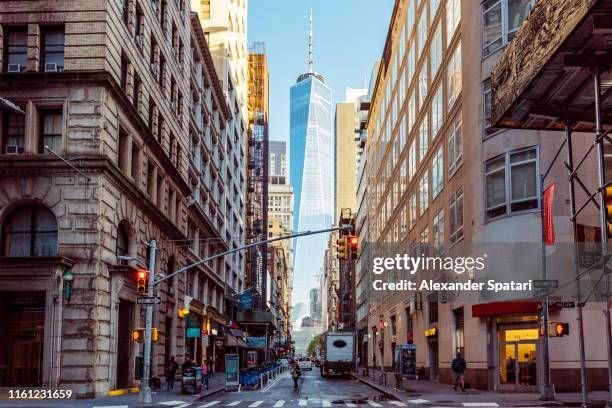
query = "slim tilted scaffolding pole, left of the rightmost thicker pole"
xmin=565 ymin=122 xmax=589 ymax=408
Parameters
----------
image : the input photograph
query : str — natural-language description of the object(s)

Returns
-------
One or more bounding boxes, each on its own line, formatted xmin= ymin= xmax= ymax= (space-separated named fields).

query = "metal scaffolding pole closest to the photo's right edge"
xmin=593 ymin=68 xmax=612 ymax=406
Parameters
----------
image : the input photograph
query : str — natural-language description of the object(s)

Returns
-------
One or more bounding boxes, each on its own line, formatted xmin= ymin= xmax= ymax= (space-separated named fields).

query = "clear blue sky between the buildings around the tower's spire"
xmin=247 ymin=0 xmax=394 ymax=141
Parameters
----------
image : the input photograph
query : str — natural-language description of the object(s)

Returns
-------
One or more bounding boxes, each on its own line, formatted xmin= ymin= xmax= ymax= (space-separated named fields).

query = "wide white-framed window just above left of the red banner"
xmin=485 ymin=148 xmax=539 ymax=218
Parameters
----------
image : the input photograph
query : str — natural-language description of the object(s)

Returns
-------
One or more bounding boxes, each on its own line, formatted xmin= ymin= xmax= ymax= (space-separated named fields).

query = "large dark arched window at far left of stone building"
xmin=2 ymin=205 xmax=57 ymax=256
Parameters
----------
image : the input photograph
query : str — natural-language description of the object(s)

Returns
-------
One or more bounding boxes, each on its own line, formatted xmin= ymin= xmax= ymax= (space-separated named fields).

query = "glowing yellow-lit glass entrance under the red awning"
xmin=499 ymin=328 xmax=538 ymax=391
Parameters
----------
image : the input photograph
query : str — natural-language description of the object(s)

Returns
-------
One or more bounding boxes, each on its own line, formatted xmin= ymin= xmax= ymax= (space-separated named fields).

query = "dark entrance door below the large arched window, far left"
xmin=0 ymin=292 xmax=45 ymax=387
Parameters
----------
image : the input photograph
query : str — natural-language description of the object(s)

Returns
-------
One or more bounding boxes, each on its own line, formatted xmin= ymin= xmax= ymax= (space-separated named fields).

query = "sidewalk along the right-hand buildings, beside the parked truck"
xmin=353 ymin=370 xmax=608 ymax=407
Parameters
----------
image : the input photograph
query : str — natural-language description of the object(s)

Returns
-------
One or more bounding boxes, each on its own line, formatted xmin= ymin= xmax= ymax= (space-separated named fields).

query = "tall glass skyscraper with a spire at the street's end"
xmin=289 ymin=11 xmax=334 ymax=310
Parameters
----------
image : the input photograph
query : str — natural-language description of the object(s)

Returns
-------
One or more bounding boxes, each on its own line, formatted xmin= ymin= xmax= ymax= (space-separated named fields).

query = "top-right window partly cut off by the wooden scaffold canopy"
xmin=482 ymin=0 xmax=536 ymax=56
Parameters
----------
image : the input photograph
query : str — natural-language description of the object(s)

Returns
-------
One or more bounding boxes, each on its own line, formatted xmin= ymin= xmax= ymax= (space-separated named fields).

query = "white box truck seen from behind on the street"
xmin=320 ymin=332 xmax=355 ymax=377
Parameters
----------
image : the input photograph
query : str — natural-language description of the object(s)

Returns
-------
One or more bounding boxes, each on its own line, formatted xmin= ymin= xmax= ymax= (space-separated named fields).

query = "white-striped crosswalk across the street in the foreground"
xmin=126 ymin=398 xmax=534 ymax=408
